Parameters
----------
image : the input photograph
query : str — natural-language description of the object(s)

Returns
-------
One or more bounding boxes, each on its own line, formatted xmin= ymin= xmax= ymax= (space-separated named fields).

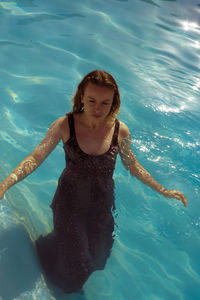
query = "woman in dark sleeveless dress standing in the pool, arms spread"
xmin=0 ymin=71 xmax=187 ymax=293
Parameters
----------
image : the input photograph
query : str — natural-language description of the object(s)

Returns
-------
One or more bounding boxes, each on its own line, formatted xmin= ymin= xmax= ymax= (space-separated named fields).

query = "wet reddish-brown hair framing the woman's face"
xmin=72 ymin=70 xmax=120 ymax=116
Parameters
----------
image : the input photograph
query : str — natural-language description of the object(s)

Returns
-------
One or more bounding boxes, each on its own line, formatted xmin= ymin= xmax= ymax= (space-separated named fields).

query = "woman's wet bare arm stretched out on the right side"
xmin=119 ymin=122 xmax=187 ymax=207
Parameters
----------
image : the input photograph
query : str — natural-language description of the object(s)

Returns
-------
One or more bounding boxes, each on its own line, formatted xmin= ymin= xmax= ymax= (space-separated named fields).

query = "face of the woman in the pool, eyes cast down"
xmin=81 ymin=82 xmax=114 ymax=120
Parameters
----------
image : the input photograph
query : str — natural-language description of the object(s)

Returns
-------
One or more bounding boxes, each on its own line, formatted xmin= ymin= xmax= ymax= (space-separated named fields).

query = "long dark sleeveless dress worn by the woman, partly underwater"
xmin=36 ymin=114 xmax=119 ymax=293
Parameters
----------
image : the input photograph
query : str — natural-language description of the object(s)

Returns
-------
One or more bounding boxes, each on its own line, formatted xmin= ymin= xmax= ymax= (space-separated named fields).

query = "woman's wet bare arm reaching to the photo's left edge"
xmin=0 ymin=118 xmax=62 ymax=199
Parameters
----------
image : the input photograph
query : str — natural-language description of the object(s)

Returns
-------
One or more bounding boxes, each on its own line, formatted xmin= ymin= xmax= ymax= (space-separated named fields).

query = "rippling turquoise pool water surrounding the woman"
xmin=0 ymin=0 xmax=200 ymax=300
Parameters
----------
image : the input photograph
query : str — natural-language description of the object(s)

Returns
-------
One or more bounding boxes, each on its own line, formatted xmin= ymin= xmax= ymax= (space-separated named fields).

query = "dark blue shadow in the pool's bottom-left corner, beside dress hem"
xmin=0 ymin=225 xmax=41 ymax=300
